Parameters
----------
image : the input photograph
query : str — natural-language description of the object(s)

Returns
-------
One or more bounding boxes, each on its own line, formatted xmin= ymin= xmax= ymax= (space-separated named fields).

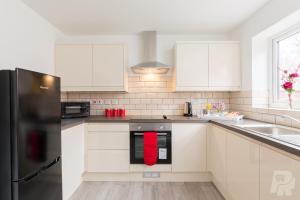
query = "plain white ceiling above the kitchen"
xmin=23 ymin=0 xmax=269 ymax=35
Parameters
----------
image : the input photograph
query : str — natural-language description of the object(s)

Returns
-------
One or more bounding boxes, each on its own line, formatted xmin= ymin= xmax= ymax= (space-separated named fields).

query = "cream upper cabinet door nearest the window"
xmin=209 ymin=44 xmax=241 ymax=88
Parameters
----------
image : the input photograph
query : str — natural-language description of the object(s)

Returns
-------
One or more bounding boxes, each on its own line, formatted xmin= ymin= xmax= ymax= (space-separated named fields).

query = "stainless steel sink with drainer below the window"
xmin=235 ymin=124 xmax=300 ymax=146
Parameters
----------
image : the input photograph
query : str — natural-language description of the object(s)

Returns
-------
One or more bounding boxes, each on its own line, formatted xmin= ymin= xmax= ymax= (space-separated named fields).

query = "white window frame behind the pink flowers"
xmin=269 ymin=25 xmax=300 ymax=110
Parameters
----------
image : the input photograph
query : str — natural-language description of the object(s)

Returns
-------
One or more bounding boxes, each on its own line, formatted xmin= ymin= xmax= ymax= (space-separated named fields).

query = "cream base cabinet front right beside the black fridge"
xmin=61 ymin=124 xmax=84 ymax=200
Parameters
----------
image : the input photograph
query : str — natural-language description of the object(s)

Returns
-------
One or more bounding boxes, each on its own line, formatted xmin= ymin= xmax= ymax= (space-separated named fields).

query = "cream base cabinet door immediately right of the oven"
xmin=172 ymin=123 xmax=206 ymax=172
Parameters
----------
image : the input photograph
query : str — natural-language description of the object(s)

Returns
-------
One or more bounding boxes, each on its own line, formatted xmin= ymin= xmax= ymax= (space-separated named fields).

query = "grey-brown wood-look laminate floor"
xmin=70 ymin=182 xmax=224 ymax=200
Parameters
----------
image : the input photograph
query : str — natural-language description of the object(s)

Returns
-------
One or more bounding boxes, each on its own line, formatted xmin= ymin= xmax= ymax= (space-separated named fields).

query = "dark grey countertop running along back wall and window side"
xmin=62 ymin=116 xmax=300 ymax=156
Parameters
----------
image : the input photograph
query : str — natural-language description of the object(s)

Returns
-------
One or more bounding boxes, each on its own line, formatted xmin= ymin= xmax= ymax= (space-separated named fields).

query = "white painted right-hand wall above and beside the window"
xmin=230 ymin=0 xmax=300 ymax=90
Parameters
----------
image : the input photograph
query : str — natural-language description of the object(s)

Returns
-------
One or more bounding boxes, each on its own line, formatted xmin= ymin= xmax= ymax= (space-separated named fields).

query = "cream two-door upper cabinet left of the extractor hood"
xmin=55 ymin=44 xmax=127 ymax=92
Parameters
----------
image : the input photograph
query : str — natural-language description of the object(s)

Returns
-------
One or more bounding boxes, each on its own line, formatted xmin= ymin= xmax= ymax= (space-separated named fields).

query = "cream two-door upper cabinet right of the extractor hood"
xmin=174 ymin=42 xmax=240 ymax=91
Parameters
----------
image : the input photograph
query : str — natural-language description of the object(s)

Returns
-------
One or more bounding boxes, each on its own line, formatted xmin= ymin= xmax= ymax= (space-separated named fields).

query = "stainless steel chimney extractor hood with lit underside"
xmin=131 ymin=31 xmax=170 ymax=74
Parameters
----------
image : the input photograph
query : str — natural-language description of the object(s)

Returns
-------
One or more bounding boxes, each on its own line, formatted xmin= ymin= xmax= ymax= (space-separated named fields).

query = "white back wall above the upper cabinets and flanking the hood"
xmin=57 ymin=34 xmax=228 ymax=74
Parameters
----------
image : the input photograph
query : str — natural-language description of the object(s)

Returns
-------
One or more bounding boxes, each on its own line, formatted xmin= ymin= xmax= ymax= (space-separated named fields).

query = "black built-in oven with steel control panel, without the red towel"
xmin=130 ymin=123 xmax=172 ymax=164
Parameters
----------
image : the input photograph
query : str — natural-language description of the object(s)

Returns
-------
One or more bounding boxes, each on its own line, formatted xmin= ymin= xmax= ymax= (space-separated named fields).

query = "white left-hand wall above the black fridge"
xmin=0 ymin=0 xmax=61 ymax=74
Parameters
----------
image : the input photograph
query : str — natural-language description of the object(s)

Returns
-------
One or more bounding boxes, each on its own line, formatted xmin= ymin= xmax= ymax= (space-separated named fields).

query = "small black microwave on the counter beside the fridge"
xmin=61 ymin=102 xmax=90 ymax=119
